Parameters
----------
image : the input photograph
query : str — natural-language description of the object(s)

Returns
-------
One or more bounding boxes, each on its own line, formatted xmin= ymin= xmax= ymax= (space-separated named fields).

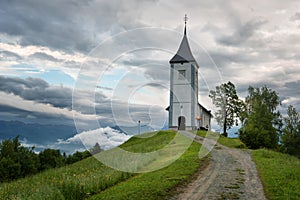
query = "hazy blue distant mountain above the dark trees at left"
xmin=0 ymin=120 xmax=77 ymax=144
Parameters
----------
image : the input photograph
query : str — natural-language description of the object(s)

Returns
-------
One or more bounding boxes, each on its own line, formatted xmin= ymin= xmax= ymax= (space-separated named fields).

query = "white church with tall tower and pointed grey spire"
xmin=166 ymin=16 xmax=212 ymax=130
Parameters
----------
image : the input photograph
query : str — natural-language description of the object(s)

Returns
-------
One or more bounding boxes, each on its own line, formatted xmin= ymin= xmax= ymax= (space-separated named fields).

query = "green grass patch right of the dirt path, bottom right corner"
xmin=252 ymin=149 xmax=300 ymax=200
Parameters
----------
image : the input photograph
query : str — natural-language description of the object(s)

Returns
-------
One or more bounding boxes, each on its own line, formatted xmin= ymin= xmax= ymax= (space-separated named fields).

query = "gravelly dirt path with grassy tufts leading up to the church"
xmin=171 ymin=132 xmax=266 ymax=200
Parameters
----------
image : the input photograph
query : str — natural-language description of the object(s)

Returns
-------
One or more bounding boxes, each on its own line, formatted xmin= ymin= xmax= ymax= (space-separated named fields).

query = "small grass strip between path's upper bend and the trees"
xmin=197 ymin=130 xmax=246 ymax=149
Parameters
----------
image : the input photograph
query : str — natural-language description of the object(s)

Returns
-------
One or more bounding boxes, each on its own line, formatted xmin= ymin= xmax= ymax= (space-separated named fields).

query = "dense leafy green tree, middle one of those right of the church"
xmin=239 ymin=86 xmax=280 ymax=149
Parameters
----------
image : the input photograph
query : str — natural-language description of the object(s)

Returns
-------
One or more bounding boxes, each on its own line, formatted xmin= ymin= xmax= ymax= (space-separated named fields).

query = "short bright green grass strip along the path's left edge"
xmin=89 ymin=140 xmax=205 ymax=200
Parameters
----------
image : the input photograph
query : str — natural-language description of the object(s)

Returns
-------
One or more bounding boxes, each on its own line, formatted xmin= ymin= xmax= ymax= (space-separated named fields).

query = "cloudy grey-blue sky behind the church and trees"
xmin=0 ymin=0 xmax=300 ymax=153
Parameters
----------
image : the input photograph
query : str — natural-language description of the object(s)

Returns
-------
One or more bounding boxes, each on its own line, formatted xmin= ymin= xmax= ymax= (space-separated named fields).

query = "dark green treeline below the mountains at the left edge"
xmin=0 ymin=137 xmax=91 ymax=182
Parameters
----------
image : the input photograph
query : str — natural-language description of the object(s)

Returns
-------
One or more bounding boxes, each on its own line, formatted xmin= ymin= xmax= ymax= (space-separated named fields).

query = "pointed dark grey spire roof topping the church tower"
xmin=170 ymin=15 xmax=195 ymax=63
